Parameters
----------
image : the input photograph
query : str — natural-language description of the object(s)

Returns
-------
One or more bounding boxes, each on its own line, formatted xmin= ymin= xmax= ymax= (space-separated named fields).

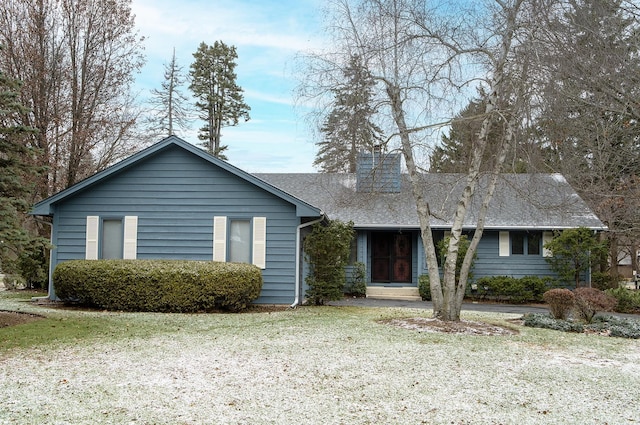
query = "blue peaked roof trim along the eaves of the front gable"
xmin=31 ymin=136 xmax=322 ymax=217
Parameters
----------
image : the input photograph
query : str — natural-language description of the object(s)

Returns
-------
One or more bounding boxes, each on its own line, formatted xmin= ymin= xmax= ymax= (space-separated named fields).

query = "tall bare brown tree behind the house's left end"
xmin=0 ymin=0 xmax=143 ymax=198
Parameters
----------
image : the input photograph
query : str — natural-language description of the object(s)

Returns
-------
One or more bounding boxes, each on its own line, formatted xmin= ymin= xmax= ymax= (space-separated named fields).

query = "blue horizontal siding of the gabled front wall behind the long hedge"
xmin=48 ymin=147 xmax=300 ymax=303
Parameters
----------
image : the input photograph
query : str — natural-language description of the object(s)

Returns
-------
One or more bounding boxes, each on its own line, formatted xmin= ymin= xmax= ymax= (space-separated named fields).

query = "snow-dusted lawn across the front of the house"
xmin=0 ymin=293 xmax=640 ymax=424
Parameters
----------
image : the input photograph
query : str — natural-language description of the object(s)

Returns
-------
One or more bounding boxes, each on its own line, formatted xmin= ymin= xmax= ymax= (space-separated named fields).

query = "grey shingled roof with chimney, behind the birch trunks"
xmin=255 ymin=173 xmax=606 ymax=229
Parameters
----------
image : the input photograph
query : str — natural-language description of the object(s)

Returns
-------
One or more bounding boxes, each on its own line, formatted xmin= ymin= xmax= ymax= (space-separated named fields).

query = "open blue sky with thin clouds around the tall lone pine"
xmin=132 ymin=0 xmax=322 ymax=172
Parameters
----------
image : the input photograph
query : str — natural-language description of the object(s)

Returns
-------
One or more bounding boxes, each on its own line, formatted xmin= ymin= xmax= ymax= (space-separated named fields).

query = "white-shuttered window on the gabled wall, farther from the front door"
xmin=85 ymin=215 xmax=138 ymax=260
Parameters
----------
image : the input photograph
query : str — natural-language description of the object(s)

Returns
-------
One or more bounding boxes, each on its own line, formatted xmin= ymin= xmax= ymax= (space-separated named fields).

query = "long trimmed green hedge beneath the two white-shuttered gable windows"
xmin=53 ymin=260 xmax=262 ymax=313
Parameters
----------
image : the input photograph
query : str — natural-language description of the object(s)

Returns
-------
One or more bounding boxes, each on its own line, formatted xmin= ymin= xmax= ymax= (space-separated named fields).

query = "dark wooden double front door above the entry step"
xmin=371 ymin=232 xmax=412 ymax=283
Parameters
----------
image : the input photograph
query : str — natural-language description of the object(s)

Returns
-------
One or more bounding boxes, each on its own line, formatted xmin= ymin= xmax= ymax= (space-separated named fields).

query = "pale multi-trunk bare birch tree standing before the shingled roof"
xmin=302 ymin=0 xmax=536 ymax=320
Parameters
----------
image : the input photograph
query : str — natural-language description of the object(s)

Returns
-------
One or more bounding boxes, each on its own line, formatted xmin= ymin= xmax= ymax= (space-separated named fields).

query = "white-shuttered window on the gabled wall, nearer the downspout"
xmin=213 ymin=216 xmax=267 ymax=269
